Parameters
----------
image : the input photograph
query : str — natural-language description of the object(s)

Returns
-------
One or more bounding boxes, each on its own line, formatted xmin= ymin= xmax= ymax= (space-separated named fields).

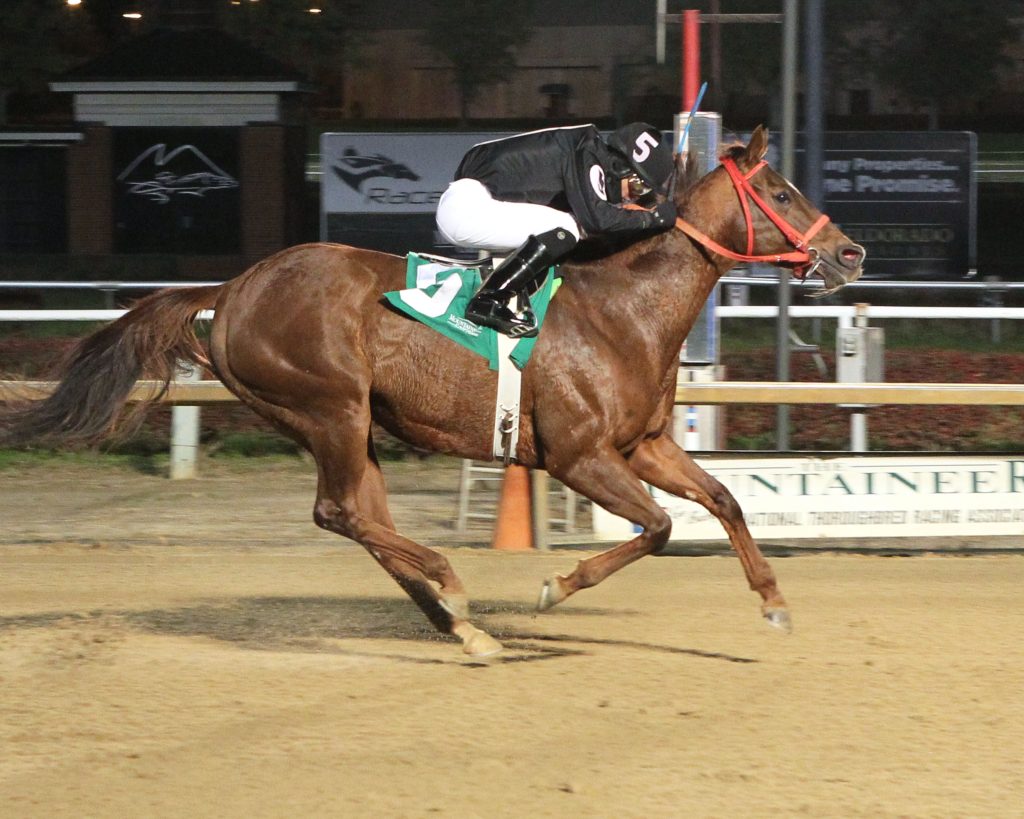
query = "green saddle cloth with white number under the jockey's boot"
xmin=384 ymin=253 xmax=561 ymax=370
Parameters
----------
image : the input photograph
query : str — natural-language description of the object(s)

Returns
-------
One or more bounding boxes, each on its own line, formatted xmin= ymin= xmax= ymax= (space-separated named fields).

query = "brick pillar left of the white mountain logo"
xmin=68 ymin=125 xmax=114 ymax=255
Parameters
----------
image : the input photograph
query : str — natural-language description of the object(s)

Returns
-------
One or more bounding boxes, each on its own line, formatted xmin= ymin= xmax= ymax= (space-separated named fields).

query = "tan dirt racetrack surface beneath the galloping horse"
xmin=0 ymin=462 xmax=1024 ymax=819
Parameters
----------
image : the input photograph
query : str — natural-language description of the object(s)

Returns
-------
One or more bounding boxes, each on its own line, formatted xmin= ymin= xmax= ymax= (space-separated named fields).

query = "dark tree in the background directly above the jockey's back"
xmin=423 ymin=0 xmax=534 ymax=122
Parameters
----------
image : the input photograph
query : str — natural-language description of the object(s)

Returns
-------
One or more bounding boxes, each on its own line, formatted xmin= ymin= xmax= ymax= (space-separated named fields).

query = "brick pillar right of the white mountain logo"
xmin=240 ymin=125 xmax=288 ymax=263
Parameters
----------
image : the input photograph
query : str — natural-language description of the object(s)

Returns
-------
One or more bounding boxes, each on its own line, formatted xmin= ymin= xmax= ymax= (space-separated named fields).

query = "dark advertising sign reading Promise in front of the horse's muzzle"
xmin=822 ymin=131 xmax=977 ymax=279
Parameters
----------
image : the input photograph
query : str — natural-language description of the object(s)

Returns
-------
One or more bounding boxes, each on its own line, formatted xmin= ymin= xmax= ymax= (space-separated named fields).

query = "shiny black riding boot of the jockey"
xmin=466 ymin=229 xmax=575 ymax=339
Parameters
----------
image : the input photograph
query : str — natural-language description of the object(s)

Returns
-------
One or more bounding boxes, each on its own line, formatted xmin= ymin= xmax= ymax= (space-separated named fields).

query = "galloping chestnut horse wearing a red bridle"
xmin=0 ymin=128 xmax=864 ymax=656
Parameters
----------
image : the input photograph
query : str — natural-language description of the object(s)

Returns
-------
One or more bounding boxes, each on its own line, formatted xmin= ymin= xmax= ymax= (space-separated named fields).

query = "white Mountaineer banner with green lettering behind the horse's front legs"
xmin=594 ymin=456 xmax=1024 ymax=541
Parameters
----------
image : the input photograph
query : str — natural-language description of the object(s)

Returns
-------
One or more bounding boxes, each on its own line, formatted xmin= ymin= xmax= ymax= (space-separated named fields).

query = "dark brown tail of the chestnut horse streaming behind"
xmin=0 ymin=285 xmax=221 ymax=446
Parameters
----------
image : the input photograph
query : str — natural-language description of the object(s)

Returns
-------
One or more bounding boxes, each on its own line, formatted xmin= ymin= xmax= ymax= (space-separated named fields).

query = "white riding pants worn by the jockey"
xmin=437 ymin=179 xmax=580 ymax=252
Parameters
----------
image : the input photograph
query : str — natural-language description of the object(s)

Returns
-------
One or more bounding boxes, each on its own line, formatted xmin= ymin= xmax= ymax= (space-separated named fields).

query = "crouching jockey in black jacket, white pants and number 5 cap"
xmin=437 ymin=123 xmax=676 ymax=338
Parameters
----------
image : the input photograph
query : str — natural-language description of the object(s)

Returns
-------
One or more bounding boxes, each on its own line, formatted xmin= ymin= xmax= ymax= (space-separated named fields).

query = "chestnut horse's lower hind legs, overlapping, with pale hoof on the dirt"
xmin=312 ymin=432 xmax=502 ymax=657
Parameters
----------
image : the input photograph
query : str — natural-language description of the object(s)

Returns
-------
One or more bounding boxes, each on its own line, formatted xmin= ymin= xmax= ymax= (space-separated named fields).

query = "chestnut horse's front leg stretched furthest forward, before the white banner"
xmin=629 ymin=435 xmax=793 ymax=632
